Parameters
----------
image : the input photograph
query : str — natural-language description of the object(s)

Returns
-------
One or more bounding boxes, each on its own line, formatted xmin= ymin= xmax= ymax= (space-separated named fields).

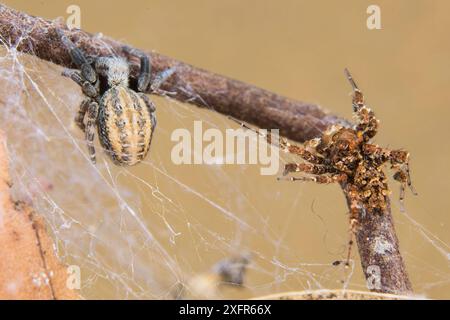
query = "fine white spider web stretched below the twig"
xmin=0 ymin=36 xmax=450 ymax=299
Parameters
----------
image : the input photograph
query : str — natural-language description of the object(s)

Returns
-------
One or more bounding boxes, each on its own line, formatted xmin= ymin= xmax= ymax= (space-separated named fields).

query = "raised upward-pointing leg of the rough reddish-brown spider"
xmin=345 ymin=69 xmax=378 ymax=142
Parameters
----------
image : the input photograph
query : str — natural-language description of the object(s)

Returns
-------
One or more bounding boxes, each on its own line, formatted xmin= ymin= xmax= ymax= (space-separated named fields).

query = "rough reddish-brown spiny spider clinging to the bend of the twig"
xmin=234 ymin=69 xmax=417 ymax=265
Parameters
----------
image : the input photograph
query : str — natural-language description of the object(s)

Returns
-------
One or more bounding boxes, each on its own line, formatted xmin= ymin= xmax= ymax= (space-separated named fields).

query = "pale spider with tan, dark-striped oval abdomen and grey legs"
xmin=58 ymin=30 xmax=174 ymax=166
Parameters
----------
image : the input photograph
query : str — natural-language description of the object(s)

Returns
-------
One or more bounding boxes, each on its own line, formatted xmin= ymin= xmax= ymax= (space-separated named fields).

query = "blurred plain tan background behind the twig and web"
xmin=4 ymin=0 xmax=450 ymax=298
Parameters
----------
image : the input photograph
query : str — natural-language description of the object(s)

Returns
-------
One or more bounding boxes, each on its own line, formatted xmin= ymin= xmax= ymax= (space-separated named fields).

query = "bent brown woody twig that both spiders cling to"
xmin=0 ymin=5 xmax=412 ymax=294
